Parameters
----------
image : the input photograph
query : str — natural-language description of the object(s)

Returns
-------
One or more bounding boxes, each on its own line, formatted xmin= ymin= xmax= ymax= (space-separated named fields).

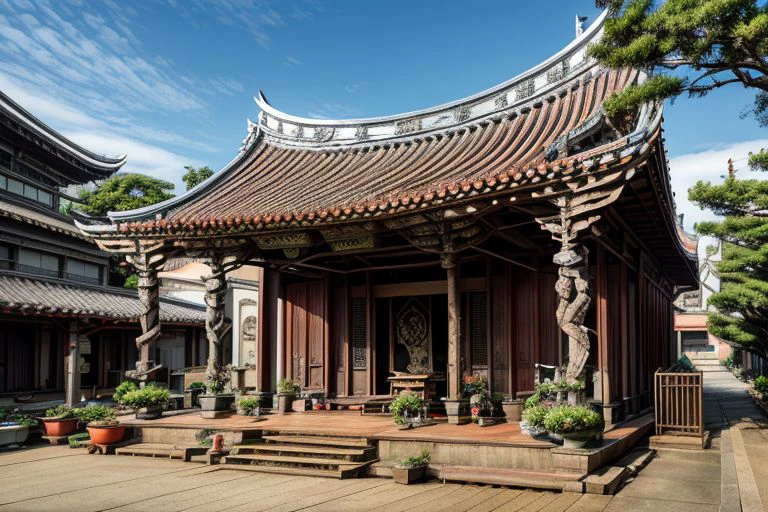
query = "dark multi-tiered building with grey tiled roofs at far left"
xmin=0 ymin=92 xmax=207 ymax=402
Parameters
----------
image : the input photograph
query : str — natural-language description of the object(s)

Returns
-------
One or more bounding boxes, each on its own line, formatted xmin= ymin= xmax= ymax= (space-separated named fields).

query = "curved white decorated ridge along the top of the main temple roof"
xmin=254 ymin=11 xmax=607 ymax=147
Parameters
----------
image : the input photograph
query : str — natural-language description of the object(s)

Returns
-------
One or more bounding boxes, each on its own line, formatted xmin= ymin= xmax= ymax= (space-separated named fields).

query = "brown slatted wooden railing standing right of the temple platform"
xmin=654 ymin=370 xmax=704 ymax=438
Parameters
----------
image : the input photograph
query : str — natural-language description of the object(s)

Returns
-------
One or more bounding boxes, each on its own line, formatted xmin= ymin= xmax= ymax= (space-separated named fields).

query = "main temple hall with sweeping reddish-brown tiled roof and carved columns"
xmin=79 ymin=12 xmax=698 ymax=423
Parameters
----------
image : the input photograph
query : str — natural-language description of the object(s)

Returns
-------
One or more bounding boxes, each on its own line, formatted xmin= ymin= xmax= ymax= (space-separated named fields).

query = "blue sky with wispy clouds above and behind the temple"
xmin=0 ymin=0 xmax=768 ymax=227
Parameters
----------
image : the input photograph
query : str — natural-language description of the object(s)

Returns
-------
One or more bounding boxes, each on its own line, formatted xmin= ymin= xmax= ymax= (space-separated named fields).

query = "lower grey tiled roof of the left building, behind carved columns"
xmin=0 ymin=274 xmax=205 ymax=325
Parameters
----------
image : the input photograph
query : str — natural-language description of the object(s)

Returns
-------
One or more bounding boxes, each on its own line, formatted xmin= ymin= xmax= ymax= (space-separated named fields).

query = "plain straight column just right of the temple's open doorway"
xmin=442 ymin=253 xmax=471 ymax=425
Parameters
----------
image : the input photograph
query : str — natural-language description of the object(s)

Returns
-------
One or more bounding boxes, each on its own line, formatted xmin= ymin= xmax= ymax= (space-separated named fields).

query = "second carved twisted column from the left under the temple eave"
xmin=205 ymin=254 xmax=227 ymax=388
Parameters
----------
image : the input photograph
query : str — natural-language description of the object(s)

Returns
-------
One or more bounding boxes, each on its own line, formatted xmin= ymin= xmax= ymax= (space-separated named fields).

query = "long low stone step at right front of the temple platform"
xmin=437 ymin=466 xmax=584 ymax=491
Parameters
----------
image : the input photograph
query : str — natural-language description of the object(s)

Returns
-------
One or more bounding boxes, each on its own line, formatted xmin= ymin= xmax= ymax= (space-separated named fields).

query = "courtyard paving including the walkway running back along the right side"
xmin=0 ymin=372 xmax=768 ymax=512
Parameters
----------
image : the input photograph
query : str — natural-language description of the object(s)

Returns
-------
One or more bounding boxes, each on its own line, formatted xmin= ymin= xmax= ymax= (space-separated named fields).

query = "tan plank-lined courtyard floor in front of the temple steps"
xmin=0 ymin=446 xmax=610 ymax=512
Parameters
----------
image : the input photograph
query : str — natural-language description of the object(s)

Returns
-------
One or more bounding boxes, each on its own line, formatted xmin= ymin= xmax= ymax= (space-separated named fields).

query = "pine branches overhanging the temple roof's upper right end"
xmin=588 ymin=0 xmax=768 ymax=124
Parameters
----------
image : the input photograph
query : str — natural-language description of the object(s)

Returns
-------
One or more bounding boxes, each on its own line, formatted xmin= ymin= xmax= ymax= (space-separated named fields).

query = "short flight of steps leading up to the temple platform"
xmin=221 ymin=433 xmax=377 ymax=478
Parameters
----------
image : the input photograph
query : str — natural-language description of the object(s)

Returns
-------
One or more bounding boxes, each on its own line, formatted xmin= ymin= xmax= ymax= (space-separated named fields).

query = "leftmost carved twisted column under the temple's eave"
xmin=125 ymin=252 xmax=166 ymax=385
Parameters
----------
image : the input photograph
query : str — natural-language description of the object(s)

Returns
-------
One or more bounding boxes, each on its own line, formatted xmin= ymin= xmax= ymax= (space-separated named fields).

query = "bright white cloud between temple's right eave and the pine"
xmin=669 ymin=139 xmax=768 ymax=232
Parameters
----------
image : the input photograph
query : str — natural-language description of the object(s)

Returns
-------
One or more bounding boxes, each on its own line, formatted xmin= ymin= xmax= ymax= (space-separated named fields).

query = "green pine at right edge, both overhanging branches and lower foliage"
xmin=589 ymin=0 xmax=768 ymax=359
